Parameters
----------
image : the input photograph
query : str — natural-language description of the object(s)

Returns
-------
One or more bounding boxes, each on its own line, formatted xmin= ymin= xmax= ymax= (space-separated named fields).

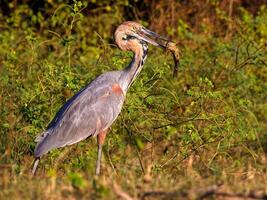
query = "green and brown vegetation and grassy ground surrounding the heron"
xmin=0 ymin=0 xmax=267 ymax=199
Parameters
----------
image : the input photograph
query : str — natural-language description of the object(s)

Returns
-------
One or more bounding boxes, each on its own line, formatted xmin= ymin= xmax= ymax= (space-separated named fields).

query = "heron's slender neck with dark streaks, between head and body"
xmin=120 ymin=44 xmax=148 ymax=92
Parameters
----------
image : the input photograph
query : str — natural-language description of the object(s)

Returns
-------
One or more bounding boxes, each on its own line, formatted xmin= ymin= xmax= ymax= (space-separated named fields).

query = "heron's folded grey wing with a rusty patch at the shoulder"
xmin=35 ymin=72 xmax=124 ymax=157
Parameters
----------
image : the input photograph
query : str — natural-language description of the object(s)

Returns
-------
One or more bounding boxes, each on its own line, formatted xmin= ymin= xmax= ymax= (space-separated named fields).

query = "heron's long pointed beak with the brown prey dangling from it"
xmin=137 ymin=27 xmax=180 ymax=77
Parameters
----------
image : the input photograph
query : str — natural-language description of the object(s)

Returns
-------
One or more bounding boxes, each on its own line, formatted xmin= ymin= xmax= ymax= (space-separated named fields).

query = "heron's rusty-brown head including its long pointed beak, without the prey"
xmin=115 ymin=21 xmax=170 ymax=51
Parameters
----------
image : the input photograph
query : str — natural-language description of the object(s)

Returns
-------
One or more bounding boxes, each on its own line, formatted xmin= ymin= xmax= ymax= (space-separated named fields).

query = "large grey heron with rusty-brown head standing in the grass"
xmin=32 ymin=21 xmax=178 ymax=175
